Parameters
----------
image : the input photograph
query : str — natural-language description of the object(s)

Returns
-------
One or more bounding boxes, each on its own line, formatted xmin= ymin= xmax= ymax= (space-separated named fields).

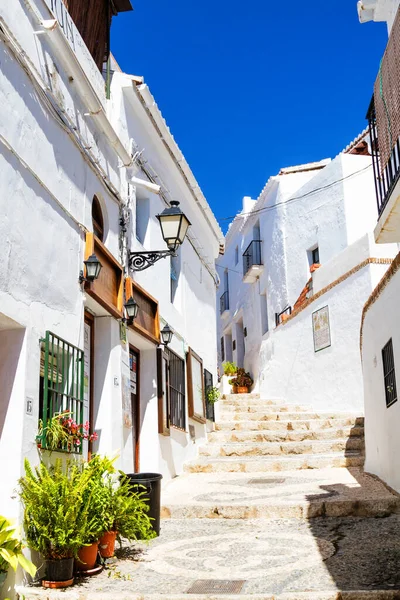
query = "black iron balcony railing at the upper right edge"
xmin=367 ymin=98 xmax=400 ymax=216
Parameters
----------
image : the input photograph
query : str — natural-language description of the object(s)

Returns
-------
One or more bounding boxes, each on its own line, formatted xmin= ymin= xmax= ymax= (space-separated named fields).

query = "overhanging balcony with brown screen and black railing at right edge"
xmin=367 ymin=5 xmax=400 ymax=243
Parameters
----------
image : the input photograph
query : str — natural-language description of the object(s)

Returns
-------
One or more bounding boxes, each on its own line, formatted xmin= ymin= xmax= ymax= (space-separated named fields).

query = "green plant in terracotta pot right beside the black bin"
xmin=99 ymin=471 xmax=156 ymax=558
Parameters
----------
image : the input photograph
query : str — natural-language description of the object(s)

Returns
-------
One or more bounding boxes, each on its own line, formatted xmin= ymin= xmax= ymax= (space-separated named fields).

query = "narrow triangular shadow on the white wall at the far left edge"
xmin=0 ymin=329 xmax=25 ymax=439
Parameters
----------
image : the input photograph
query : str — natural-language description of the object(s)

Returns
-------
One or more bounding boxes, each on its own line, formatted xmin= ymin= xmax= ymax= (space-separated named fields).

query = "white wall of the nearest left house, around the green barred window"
xmin=0 ymin=0 xmax=120 ymax=515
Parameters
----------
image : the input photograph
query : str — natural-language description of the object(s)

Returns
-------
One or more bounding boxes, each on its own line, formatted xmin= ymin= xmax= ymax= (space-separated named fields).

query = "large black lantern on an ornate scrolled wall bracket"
xmin=129 ymin=200 xmax=191 ymax=271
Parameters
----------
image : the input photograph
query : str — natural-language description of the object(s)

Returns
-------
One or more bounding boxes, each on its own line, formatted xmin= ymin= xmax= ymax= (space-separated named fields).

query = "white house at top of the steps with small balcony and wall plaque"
xmin=217 ymin=139 xmax=396 ymax=414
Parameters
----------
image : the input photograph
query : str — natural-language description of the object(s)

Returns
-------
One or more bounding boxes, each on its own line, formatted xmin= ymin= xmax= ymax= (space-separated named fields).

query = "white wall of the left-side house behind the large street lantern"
xmin=111 ymin=73 xmax=222 ymax=481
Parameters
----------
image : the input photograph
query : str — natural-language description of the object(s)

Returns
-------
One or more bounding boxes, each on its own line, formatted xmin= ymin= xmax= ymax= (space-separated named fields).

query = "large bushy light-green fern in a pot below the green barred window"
xmin=19 ymin=459 xmax=97 ymax=588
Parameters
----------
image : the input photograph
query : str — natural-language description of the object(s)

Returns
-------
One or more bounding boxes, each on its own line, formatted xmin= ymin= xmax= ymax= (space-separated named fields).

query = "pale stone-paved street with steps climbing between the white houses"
xmin=24 ymin=395 xmax=400 ymax=600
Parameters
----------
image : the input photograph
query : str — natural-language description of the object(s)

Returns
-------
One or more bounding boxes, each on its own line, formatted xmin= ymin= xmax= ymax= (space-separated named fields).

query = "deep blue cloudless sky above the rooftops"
xmin=112 ymin=0 xmax=387 ymax=230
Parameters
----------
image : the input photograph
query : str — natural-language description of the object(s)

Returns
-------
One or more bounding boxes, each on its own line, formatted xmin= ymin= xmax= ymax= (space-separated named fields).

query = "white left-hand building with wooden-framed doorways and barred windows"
xmin=0 ymin=0 xmax=224 ymax=594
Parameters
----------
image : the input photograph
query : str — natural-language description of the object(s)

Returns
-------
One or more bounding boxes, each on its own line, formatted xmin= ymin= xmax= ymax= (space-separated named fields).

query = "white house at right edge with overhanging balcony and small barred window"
xmin=359 ymin=0 xmax=400 ymax=491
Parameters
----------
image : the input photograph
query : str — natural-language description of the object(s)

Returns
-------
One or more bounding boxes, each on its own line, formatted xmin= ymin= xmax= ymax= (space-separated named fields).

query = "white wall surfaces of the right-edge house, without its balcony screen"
xmin=361 ymin=0 xmax=400 ymax=492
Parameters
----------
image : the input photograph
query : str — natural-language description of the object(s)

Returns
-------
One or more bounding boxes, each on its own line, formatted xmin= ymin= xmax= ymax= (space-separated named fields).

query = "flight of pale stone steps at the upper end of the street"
xmin=185 ymin=394 xmax=364 ymax=473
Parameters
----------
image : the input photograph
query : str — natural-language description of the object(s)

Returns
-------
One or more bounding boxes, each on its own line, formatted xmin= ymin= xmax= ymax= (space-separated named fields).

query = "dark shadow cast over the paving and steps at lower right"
xmin=307 ymin=420 xmax=400 ymax=597
